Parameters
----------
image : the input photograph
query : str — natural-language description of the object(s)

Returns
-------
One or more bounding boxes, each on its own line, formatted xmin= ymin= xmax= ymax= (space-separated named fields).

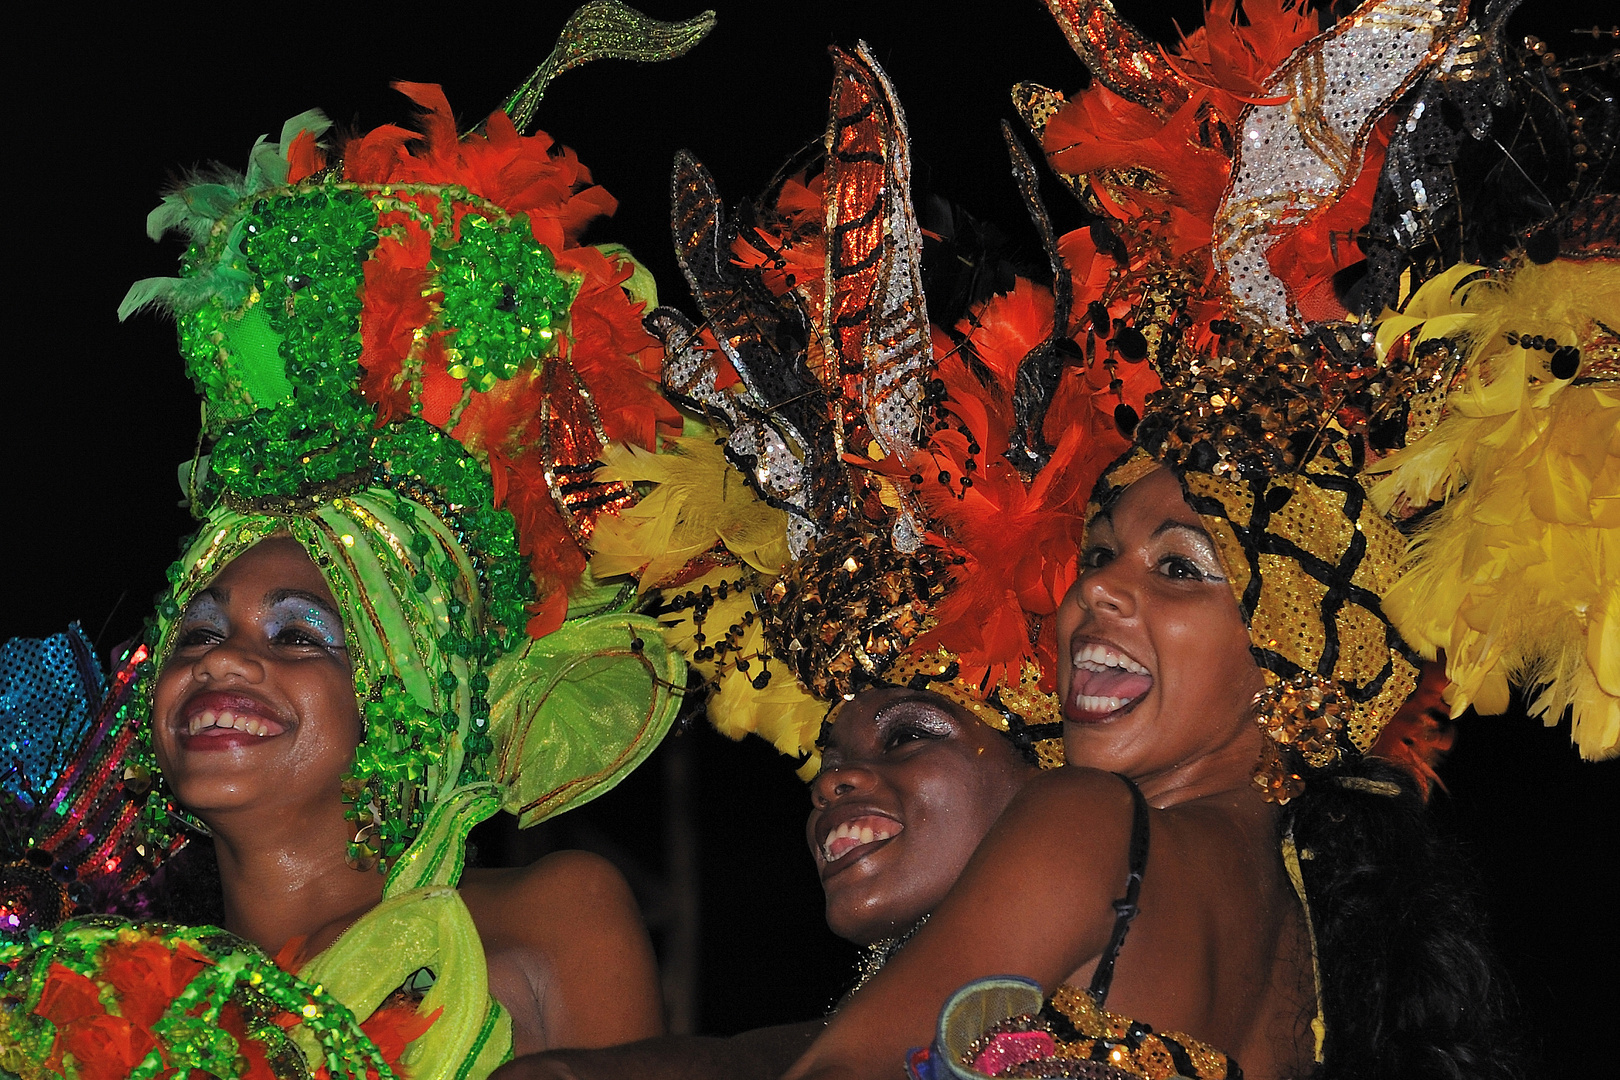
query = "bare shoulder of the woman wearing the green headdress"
xmin=462 ymin=852 xmax=664 ymax=1054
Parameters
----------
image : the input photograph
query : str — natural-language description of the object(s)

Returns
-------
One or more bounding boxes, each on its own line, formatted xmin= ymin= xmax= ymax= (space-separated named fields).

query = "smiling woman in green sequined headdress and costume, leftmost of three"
xmin=0 ymin=5 xmax=722 ymax=1080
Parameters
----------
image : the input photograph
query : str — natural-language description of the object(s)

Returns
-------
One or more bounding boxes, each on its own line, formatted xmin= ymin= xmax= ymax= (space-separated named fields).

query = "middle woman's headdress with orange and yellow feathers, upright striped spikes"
xmin=593 ymin=45 xmax=1124 ymax=776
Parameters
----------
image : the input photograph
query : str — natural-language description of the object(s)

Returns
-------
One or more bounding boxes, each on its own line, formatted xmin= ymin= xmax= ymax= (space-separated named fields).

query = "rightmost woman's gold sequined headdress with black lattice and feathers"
xmin=1014 ymin=0 xmax=1620 ymax=800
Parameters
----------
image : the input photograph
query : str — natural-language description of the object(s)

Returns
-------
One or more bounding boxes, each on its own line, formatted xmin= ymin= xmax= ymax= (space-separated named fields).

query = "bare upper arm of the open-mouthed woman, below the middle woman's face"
xmin=786 ymin=769 xmax=1131 ymax=1080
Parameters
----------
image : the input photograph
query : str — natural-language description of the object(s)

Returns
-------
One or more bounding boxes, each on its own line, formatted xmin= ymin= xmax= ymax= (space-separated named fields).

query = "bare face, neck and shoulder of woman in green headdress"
xmin=152 ymin=536 xmax=663 ymax=1052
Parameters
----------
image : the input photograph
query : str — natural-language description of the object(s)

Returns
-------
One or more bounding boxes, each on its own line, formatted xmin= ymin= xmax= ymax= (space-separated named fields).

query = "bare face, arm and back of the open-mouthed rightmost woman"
xmin=774 ymin=471 xmax=1314 ymax=1078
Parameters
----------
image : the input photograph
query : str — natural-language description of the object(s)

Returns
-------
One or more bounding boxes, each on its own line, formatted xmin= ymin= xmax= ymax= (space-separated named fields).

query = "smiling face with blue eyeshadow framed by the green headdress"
xmin=152 ymin=536 xmax=360 ymax=819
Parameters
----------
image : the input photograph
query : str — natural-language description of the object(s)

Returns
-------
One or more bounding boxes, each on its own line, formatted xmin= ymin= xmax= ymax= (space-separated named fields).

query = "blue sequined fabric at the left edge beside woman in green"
xmin=0 ymin=623 xmax=102 ymax=806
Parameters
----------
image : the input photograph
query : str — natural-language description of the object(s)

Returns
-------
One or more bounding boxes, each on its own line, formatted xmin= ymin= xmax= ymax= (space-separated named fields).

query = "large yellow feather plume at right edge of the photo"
xmin=1369 ymin=259 xmax=1620 ymax=759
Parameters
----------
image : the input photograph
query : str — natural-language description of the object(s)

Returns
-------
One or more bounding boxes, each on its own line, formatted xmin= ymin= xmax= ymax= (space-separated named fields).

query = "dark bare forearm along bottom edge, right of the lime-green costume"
xmin=491 ymin=1020 xmax=826 ymax=1080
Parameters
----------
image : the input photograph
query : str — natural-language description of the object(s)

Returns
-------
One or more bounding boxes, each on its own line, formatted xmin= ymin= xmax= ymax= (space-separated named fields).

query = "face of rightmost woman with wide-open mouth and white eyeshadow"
xmin=1058 ymin=470 xmax=1265 ymax=780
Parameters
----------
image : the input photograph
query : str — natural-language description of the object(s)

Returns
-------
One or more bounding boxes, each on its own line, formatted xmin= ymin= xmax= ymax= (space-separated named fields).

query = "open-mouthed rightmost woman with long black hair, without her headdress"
xmin=787 ymin=450 xmax=1515 ymax=1080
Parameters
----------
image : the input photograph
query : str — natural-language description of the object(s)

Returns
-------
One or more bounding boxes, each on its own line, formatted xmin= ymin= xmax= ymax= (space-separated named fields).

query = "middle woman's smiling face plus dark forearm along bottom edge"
xmin=496 ymin=687 xmax=1037 ymax=1080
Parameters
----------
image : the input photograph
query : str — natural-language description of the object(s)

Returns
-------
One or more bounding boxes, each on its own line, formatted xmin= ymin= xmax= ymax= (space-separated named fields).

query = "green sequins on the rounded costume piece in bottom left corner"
xmin=0 ymin=916 xmax=395 ymax=1080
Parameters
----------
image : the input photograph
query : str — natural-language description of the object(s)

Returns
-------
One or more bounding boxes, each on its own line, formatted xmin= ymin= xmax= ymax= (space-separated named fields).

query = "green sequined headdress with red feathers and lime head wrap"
xmin=107 ymin=46 xmax=706 ymax=891
